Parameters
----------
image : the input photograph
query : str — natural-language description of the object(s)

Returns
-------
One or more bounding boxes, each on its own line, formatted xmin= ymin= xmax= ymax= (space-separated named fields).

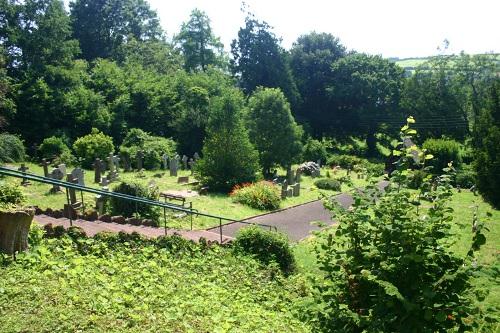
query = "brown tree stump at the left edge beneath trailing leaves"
xmin=0 ymin=209 xmax=35 ymax=254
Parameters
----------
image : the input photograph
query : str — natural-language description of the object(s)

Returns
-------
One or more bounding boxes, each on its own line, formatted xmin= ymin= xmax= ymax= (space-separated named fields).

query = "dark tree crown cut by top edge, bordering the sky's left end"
xmin=70 ymin=0 xmax=163 ymax=61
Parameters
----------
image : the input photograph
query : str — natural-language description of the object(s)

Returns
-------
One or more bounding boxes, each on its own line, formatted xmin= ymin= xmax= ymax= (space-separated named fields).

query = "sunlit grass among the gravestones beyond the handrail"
xmin=0 ymin=163 xmax=372 ymax=229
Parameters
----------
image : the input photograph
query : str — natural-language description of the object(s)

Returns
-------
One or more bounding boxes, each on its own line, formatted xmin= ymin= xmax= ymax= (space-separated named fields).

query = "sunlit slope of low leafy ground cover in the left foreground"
xmin=0 ymin=240 xmax=309 ymax=333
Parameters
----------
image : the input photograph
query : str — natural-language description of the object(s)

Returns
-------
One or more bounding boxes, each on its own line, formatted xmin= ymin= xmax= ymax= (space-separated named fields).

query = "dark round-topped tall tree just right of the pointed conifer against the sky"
xmin=290 ymin=32 xmax=346 ymax=131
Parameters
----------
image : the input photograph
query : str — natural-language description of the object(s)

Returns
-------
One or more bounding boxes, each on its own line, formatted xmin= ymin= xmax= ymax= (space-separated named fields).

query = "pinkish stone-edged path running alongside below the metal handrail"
xmin=34 ymin=215 xmax=232 ymax=243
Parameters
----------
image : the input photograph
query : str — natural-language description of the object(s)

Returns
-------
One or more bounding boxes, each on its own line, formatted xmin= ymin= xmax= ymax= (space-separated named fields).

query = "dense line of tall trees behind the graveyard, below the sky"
xmin=0 ymin=0 xmax=499 ymax=195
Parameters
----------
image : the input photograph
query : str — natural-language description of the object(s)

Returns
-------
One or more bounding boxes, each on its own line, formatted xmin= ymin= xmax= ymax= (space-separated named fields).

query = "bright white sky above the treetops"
xmin=148 ymin=0 xmax=500 ymax=58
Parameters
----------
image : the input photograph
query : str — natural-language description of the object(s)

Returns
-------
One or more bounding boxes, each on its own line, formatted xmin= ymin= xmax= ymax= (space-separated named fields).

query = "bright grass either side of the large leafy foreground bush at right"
xmin=294 ymin=190 xmax=500 ymax=332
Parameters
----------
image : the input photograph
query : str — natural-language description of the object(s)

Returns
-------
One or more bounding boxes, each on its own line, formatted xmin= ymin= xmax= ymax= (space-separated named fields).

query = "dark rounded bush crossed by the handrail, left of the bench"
xmin=110 ymin=182 xmax=159 ymax=222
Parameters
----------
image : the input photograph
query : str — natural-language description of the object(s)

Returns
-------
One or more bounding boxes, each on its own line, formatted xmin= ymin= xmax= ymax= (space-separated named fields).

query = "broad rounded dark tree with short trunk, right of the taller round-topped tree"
xmin=325 ymin=53 xmax=404 ymax=155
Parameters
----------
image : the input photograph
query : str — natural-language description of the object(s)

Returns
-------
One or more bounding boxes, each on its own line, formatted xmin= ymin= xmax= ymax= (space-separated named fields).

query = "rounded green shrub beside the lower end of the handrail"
xmin=233 ymin=226 xmax=295 ymax=274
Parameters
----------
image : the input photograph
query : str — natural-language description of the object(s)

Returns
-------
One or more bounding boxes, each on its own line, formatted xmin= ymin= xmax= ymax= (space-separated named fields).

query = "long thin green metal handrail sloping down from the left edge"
xmin=0 ymin=166 xmax=277 ymax=243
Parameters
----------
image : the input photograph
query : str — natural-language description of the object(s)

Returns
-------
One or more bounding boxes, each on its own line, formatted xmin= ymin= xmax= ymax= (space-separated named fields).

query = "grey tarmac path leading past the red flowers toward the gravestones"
xmin=208 ymin=181 xmax=387 ymax=241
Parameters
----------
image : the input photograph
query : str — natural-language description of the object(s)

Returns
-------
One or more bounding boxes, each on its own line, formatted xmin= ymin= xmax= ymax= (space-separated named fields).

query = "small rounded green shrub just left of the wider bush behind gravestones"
xmin=73 ymin=128 xmax=115 ymax=168
